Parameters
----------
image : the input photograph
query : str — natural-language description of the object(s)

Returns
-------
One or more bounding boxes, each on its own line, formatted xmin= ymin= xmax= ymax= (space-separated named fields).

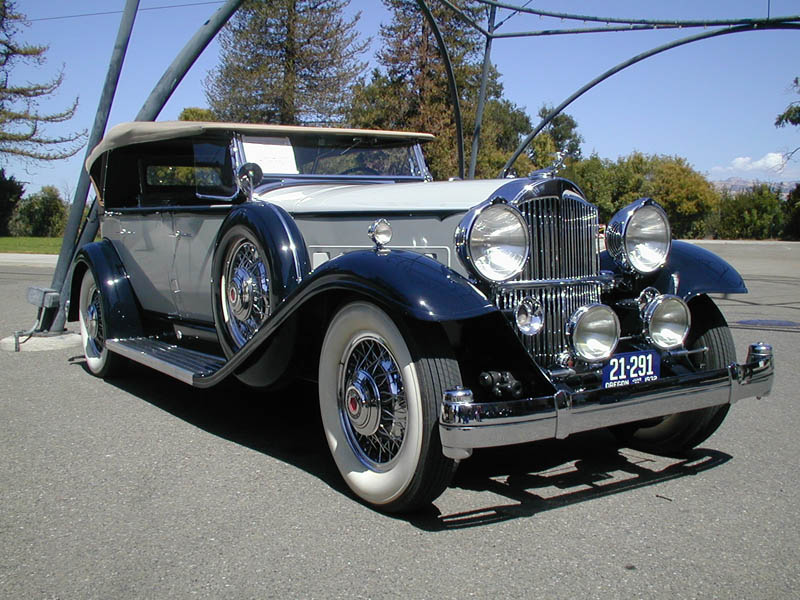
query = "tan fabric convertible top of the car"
xmin=86 ymin=121 xmax=434 ymax=170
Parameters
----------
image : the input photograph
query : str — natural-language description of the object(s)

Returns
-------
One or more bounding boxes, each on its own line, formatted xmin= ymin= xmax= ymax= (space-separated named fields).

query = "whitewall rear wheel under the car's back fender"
xmin=78 ymin=268 xmax=125 ymax=377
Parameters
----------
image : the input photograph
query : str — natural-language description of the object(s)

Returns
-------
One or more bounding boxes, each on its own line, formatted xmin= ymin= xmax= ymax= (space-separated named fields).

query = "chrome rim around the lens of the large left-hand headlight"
xmin=455 ymin=198 xmax=530 ymax=284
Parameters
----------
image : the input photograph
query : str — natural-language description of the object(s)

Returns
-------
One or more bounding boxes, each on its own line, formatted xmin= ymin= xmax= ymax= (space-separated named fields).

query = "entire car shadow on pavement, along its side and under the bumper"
xmin=76 ymin=357 xmax=731 ymax=531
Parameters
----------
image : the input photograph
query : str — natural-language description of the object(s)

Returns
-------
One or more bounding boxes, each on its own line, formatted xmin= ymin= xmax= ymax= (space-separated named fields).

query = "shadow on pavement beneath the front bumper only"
xmin=412 ymin=430 xmax=731 ymax=531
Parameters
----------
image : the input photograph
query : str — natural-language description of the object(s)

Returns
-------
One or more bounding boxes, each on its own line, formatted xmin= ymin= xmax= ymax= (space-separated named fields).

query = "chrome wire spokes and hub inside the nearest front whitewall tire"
xmin=338 ymin=335 xmax=408 ymax=471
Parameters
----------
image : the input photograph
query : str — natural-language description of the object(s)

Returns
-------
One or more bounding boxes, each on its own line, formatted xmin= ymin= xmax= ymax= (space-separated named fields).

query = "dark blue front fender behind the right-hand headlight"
xmin=600 ymin=241 xmax=747 ymax=301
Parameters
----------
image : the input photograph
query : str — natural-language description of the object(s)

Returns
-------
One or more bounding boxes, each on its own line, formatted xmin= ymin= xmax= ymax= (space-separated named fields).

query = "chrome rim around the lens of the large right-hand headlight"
xmin=606 ymin=198 xmax=672 ymax=275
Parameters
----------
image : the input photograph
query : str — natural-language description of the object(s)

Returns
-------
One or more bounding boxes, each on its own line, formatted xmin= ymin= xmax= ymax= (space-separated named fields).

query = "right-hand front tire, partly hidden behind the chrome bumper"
xmin=613 ymin=296 xmax=736 ymax=456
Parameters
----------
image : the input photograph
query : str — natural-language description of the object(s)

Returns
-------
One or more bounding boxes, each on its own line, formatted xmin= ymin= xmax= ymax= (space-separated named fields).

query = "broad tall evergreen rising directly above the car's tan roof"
xmin=204 ymin=0 xmax=369 ymax=125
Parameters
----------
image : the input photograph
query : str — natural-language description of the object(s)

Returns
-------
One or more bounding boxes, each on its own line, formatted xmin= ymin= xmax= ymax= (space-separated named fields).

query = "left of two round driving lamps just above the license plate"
xmin=567 ymin=304 xmax=620 ymax=362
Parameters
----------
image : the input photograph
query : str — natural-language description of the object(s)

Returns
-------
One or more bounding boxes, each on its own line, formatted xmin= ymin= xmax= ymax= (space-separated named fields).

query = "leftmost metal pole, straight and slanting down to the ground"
xmin=42 ymin=0 xmax=139 ymax=332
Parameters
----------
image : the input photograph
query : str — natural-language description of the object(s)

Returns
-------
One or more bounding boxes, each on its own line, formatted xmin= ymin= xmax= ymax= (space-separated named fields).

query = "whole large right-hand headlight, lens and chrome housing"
xmin=606 ymin=198 xmax=672 ymax=274
